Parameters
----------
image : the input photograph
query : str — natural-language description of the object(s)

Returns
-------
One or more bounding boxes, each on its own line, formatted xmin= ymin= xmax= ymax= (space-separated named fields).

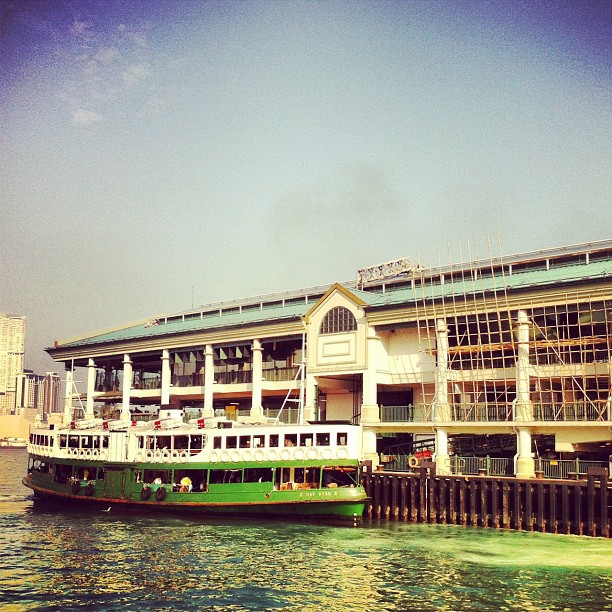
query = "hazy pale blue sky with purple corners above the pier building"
xmin=0 ymin=0 xmax=612 ymax=373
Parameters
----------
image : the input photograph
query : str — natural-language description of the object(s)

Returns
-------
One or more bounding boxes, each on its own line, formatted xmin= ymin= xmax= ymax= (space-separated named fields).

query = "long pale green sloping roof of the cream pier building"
xmin=47 ymin=240 xmax=612 ymax=356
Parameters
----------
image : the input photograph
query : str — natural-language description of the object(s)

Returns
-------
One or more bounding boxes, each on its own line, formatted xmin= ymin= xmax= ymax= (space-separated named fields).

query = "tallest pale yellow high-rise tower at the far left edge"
xmin=0 ymin=313 xmax=25 ymax=414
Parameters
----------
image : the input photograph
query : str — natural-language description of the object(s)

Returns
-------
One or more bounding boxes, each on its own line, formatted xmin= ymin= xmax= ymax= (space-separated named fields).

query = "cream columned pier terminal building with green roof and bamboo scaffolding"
xmin=47 ymin=241 xmax=612 ymax=478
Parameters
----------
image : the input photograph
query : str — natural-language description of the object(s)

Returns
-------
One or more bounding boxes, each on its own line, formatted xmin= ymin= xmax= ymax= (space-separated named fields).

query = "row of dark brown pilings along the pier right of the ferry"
xmin=364 ymin=463 xmax=612 ymax=538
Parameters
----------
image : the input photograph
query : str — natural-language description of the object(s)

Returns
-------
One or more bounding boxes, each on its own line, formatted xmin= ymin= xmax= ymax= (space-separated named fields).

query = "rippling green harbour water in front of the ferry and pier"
xmin=0 ymin=449 xmax=612 ymax=612
